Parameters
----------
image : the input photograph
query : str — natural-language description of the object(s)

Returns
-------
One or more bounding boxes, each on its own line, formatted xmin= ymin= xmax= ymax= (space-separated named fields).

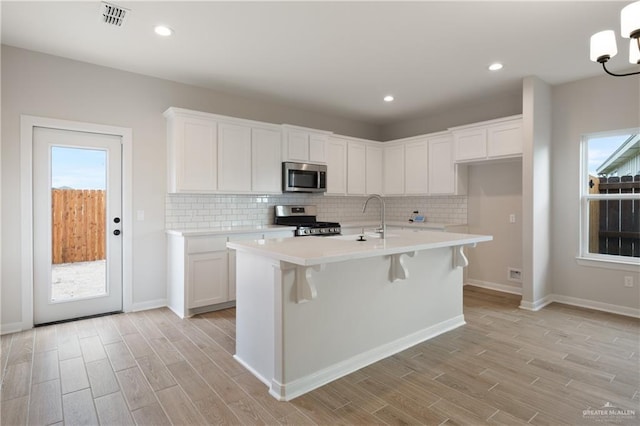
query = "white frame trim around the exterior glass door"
xmin=20 ymin=115 xmax=133 ymax=330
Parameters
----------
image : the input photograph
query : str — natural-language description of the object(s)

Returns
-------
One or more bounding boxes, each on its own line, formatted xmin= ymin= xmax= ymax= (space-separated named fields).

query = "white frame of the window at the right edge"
xmin=576 ymin=128 xmax=640 ymax=272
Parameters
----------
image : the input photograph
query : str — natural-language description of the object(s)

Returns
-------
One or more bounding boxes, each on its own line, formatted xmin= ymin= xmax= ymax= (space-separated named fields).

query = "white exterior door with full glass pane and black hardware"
xmin=33 ymin=127 xmax=122 ymax=324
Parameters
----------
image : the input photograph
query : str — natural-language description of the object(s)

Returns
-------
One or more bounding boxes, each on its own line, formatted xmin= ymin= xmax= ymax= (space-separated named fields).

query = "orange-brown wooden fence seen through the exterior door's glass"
xmin=51 ymin=189 xmax=106 ymax=264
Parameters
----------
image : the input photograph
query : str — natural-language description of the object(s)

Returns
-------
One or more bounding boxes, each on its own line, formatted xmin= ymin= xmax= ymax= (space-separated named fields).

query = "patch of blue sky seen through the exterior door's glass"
xmin=51 ymin=146 xmax=107 ymax=189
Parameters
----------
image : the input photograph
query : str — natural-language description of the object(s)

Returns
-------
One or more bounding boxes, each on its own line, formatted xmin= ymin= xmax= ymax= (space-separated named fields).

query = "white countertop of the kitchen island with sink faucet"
xmin=227 ymin=230 xmax=493 ymax=266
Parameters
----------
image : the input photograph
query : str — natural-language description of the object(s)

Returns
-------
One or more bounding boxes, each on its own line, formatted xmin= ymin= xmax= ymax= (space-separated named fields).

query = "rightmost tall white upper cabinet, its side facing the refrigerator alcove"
xmin=427 ymin=133 xmax=467 ymax=195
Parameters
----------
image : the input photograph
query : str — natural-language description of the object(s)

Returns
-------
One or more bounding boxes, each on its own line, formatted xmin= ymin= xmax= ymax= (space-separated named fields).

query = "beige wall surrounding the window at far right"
xmin=551 ymin=70 xmax=640 ymax=310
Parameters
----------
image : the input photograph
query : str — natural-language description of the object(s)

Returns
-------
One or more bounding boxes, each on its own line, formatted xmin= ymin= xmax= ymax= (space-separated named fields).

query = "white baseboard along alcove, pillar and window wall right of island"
xmin=465 ymin=279 xmax=640 ymax=318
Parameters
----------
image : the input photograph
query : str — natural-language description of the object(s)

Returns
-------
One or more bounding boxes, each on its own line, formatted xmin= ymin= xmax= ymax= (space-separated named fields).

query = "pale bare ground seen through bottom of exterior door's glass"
xmin=51 ymin=260 xmax=106 ymax=300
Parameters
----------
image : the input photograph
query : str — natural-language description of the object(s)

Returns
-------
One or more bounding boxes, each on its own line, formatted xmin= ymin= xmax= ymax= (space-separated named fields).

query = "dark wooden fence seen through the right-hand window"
xmin=589 ymin=175 xmax=640 ymax=257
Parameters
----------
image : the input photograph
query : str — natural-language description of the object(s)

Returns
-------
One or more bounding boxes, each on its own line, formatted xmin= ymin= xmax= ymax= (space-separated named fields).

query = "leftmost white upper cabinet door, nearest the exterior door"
xmin=175 ymin=117 xmax=218 ymax=192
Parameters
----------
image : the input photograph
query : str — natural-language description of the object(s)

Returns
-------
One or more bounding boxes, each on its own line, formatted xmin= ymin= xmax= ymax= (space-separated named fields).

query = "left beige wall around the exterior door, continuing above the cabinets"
xmin=1 ymin=46 xmax=380 ymax=332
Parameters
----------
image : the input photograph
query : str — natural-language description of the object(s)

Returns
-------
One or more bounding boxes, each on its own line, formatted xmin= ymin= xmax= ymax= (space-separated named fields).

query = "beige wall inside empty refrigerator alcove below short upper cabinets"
xmin=467 ymin=160 xmax=522 ymax=293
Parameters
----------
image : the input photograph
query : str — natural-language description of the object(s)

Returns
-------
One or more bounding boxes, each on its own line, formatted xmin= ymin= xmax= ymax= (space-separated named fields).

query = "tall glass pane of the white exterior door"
xmin=49 ymin=146 xmax=107 ymax=302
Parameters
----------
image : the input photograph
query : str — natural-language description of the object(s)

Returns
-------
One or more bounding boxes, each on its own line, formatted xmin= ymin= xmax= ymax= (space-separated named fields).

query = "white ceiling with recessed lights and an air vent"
xmin=1 ymin=0 xmax=631 ymax=125
